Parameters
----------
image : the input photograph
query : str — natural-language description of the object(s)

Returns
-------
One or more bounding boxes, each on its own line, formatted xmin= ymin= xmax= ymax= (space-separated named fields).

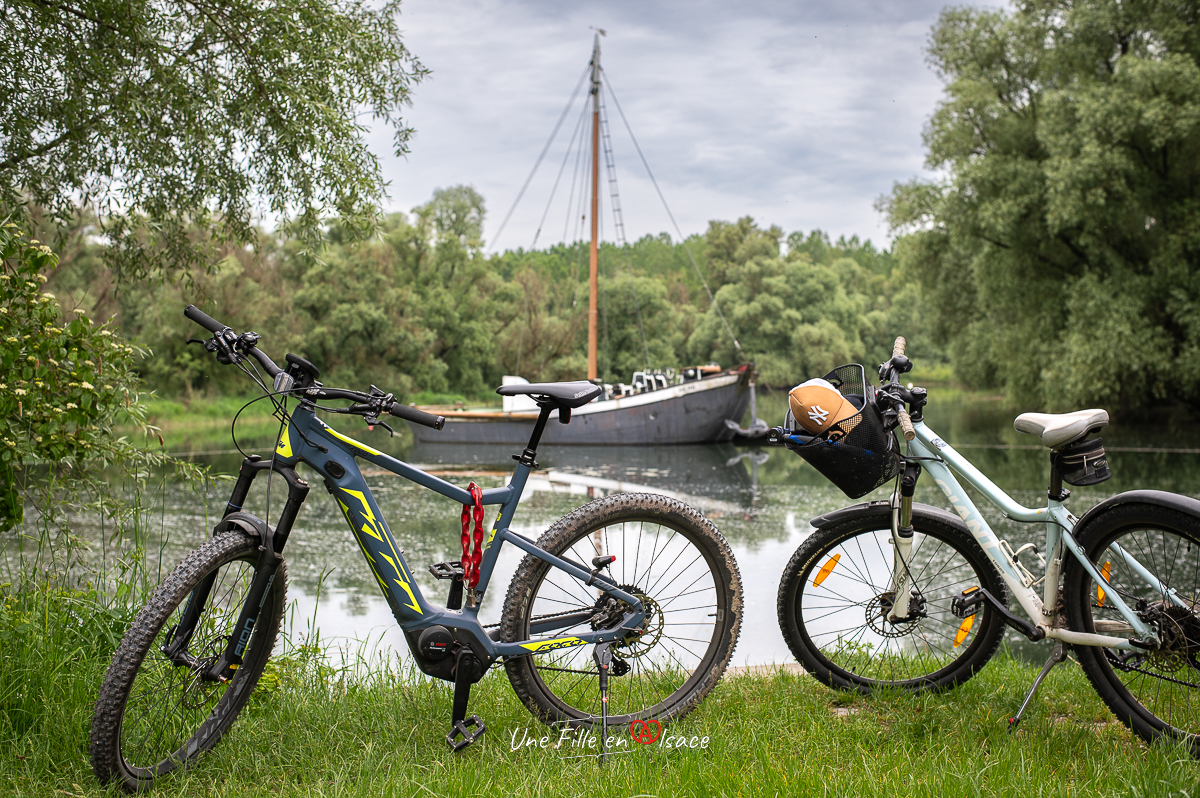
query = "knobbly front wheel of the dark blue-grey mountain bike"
xmin=91 ymin=529 xmax=287 ymax=791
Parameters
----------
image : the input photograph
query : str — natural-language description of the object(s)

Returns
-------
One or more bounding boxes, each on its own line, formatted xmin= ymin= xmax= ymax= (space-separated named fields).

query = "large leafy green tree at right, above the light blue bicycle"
xmin=881 ymin=0 xmax=1200 ymax=409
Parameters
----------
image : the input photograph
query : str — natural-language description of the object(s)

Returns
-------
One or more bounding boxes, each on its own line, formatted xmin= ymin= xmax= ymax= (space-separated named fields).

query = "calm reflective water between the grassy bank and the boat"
xmin=6 ymin=389 xmax=1200 ymax=665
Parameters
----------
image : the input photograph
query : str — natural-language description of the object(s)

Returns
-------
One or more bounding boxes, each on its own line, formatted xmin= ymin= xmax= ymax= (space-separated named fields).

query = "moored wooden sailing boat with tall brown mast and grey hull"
xmin=409 ymin=34 xmax=767 ymax=446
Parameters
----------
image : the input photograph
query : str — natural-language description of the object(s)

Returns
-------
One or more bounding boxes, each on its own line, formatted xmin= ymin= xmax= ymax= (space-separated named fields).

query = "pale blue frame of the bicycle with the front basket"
xmin=907 ymin=421 xmax=1161 ymax=650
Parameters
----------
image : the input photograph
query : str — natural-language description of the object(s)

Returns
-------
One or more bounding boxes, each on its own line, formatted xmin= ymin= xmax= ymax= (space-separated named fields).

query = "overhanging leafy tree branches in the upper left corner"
xmin=0 ymin=0 xmax=427 ymax=275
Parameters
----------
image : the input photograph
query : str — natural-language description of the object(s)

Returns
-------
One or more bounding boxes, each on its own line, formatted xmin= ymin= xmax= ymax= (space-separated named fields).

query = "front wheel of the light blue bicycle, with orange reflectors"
xmin=778 ymin=506 xmax=1008 ymax=692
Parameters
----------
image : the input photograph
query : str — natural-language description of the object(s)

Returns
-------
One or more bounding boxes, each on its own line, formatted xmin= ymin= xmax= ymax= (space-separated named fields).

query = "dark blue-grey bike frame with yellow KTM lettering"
xmin=205 ymin=404 xmax=646 ymax=667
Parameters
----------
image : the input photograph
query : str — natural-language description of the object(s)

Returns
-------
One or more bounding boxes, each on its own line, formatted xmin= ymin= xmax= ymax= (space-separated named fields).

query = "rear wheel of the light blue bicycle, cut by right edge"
xmin=1063 ymin=504 xmax=1200 ymax=756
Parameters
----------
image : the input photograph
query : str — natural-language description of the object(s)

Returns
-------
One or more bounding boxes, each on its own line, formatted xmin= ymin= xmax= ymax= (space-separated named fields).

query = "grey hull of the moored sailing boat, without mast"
xmin=409 ymin=371 xmax=750 ymax=446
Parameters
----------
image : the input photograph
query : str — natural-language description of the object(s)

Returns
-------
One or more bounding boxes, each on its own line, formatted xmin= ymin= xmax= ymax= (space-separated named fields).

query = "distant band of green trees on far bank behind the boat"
xmin=42 ymin=186 xmax=921 ymax=402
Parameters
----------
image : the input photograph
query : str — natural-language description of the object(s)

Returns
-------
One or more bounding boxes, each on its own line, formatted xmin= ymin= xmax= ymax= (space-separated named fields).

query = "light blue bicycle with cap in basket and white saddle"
xmin=772 ymin=338 xmax=1200 ymax=755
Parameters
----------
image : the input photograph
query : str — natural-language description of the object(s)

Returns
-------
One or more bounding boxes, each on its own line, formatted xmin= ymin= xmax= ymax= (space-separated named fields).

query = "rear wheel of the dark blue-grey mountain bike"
xmin=500 ymin=493 xmax=742 ymax=725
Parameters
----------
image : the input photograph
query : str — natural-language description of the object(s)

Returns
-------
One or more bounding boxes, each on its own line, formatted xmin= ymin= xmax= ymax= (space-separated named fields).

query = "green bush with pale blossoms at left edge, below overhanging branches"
xmin=0 ymin=222 xmax=168 ymax=529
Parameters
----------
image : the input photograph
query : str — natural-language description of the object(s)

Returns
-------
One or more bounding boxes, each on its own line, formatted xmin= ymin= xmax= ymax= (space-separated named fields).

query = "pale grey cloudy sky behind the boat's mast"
xmin=371 ymin=0 xmax=984 ymax=248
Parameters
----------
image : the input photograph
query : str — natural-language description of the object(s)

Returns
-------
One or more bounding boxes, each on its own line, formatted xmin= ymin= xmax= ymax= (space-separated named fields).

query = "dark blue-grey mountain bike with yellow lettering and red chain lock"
xmin=91 ymin=306 xmax=742 ymax=790
